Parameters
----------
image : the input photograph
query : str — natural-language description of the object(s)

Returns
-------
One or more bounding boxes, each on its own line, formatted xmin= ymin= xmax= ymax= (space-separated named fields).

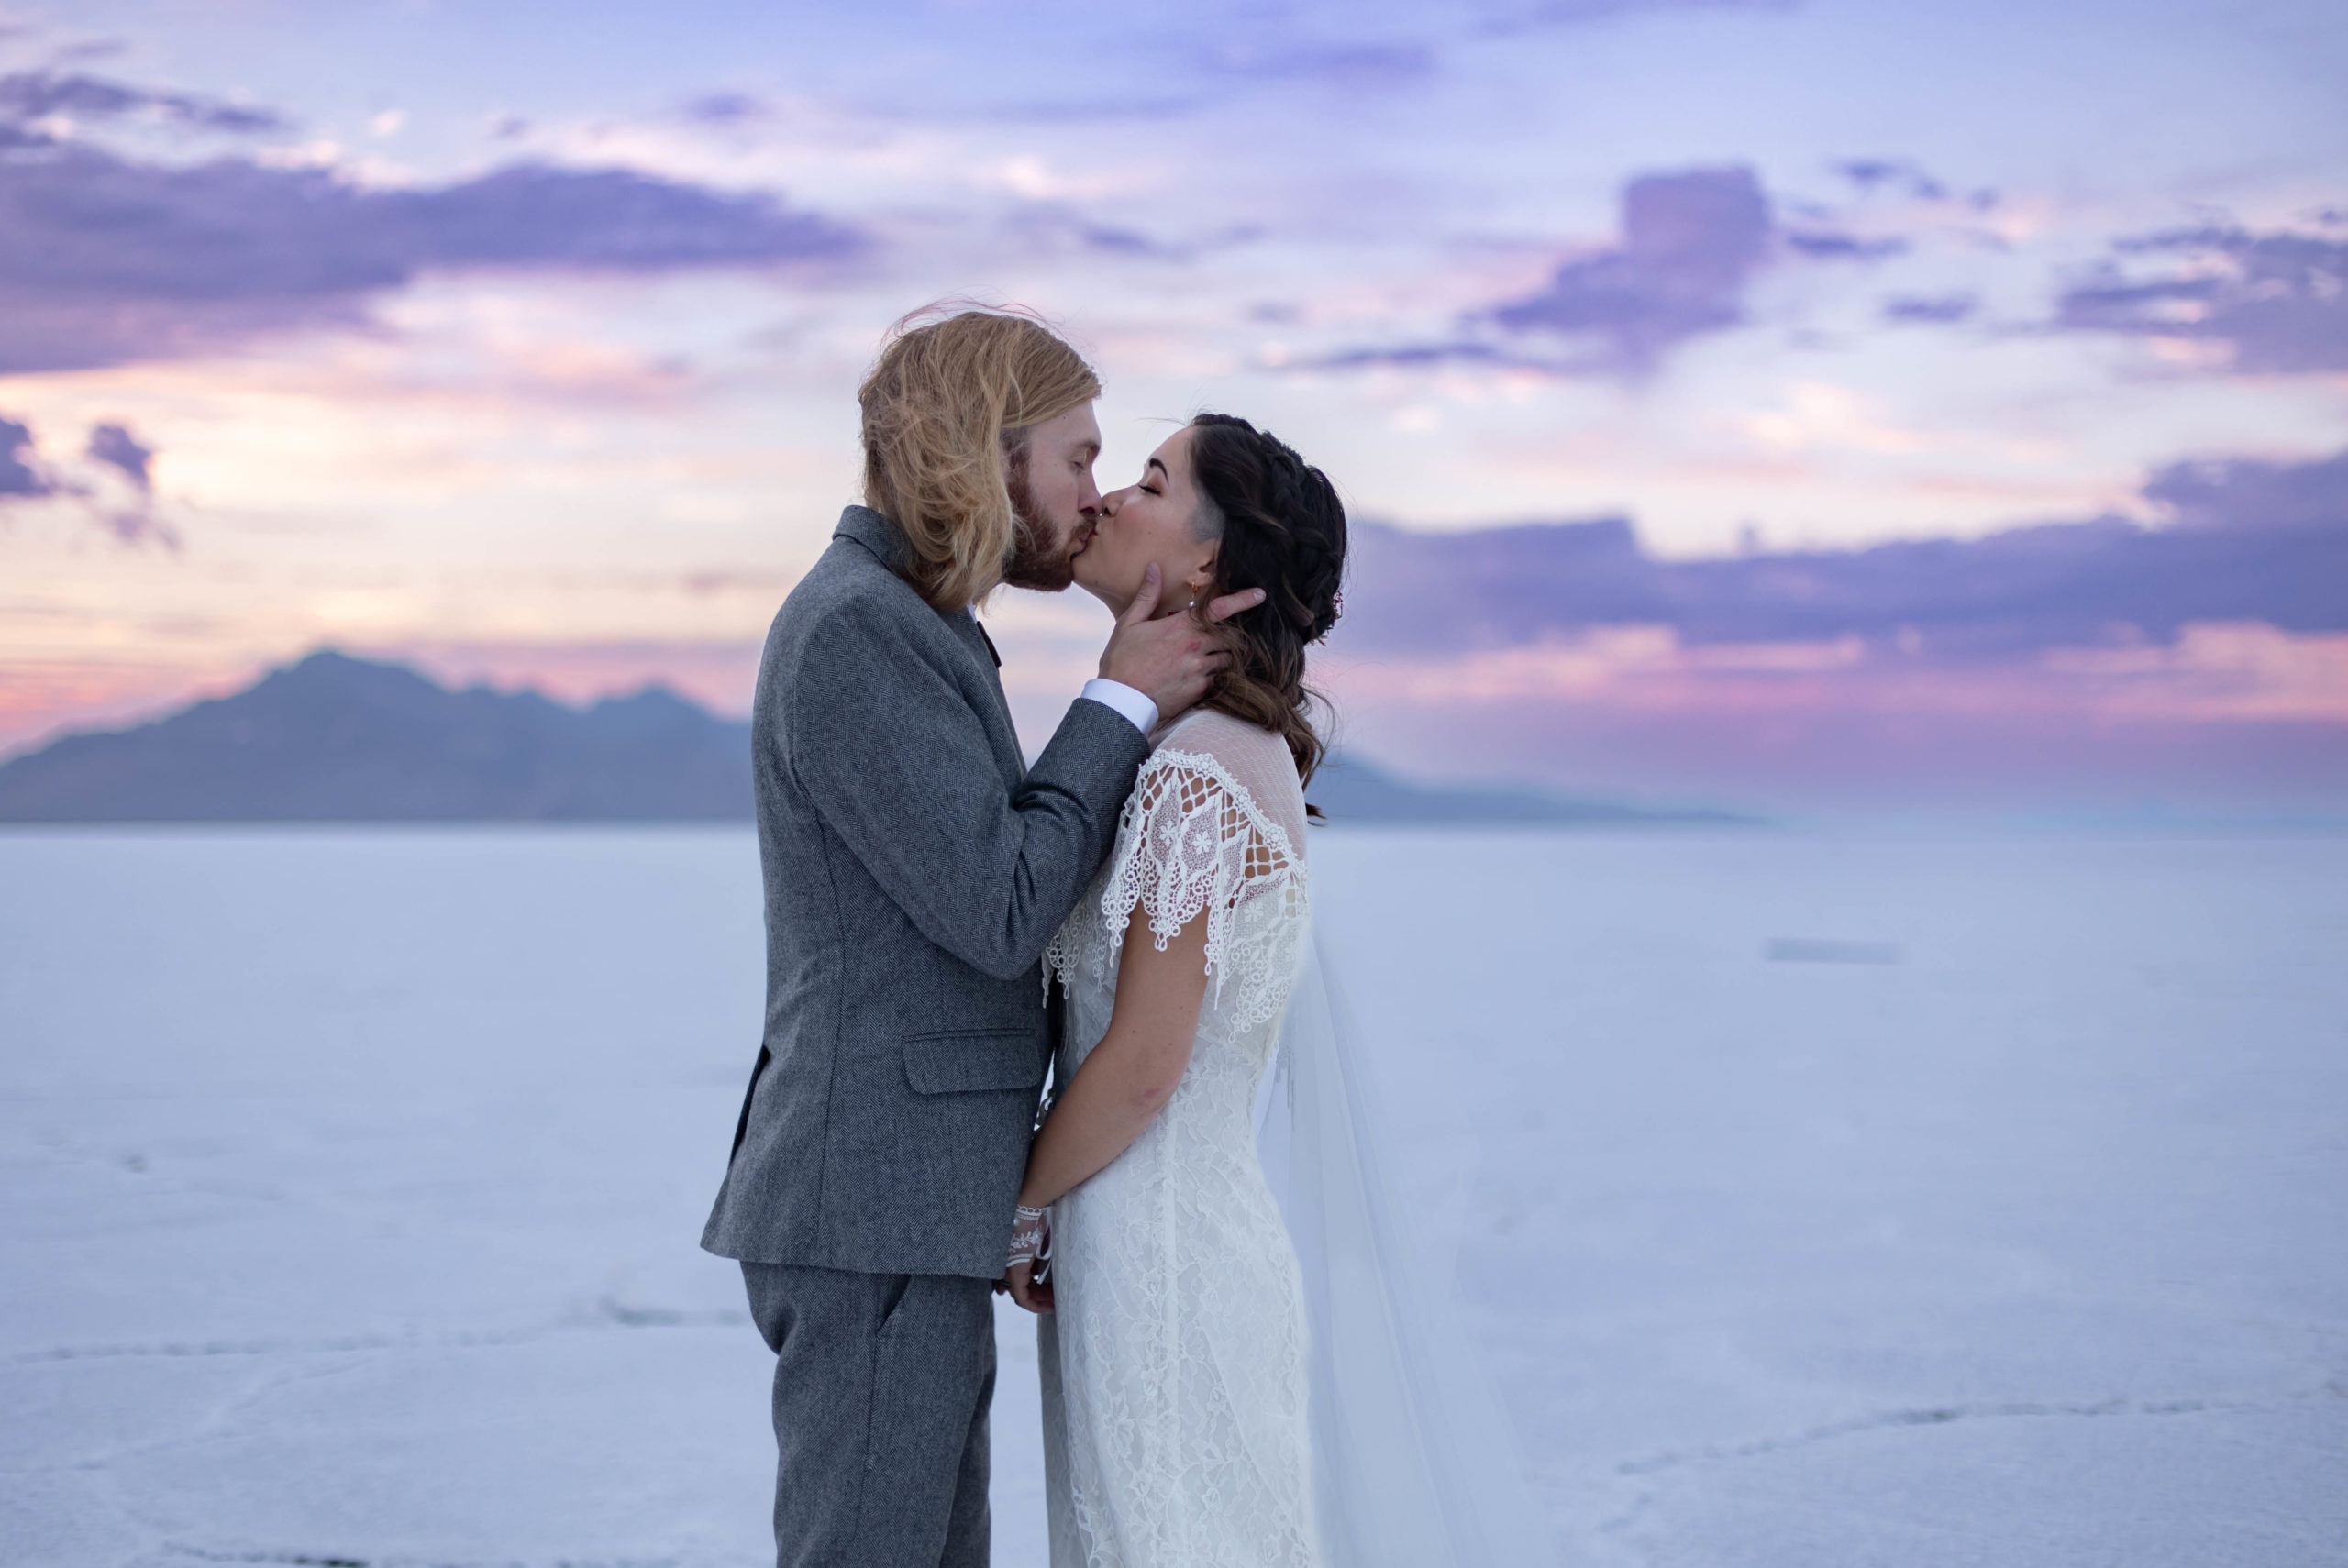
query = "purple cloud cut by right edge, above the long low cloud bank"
xmin=2054 ymin=227 xmax=2348 ymax=376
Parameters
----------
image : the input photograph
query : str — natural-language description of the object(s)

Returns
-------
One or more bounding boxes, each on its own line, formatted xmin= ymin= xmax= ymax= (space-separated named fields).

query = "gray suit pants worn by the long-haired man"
xmin=742 ymin=1263 xmax=995 ymax=1568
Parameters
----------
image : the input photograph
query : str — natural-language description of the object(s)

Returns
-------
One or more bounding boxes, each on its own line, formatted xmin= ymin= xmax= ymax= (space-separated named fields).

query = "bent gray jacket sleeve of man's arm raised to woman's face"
xmin=784 ymin=601 xmax=1148 ymax=978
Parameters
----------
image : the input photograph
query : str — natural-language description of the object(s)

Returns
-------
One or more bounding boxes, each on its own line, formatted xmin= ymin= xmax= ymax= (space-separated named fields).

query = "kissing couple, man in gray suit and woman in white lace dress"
xmin=702 ymin=310 xmax=1540 ymax=1568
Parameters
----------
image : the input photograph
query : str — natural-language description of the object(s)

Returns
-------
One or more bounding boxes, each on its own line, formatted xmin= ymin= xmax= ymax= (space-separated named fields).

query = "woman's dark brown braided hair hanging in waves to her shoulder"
xmin=1191 ymin=414 xmax=1346 ymax=784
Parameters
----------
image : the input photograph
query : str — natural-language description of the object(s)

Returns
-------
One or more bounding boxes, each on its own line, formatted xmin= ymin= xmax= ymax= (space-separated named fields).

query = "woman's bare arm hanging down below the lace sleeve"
xmin=1019 ymin=911 xmax=1207 ymax=1209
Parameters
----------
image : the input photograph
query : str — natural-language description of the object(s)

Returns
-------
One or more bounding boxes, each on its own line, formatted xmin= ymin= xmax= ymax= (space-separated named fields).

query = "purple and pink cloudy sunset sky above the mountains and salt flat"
xmin=0 ymin=0 xmax=2348 ymax=810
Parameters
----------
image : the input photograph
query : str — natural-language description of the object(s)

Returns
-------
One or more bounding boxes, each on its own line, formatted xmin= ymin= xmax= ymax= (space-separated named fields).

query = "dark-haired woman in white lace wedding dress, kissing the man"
xmin=1005 ymin=414 xmax=1346 ymax=1568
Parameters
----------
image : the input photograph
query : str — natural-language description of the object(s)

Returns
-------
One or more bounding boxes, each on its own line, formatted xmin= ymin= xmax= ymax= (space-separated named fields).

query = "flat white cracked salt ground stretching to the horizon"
xmin=0 ymin=831 xmax=2348 ymax=1568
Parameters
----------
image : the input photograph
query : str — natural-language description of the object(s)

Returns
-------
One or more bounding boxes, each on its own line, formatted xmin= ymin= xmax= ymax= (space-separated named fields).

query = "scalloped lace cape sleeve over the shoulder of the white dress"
xmin=1045 ymin=749 xmax=1305 ymax=1031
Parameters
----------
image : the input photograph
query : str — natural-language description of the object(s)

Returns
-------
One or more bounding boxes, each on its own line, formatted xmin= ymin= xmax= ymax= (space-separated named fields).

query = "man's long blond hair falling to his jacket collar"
xmin=857 ymin=305 xmax=1102 ymax=611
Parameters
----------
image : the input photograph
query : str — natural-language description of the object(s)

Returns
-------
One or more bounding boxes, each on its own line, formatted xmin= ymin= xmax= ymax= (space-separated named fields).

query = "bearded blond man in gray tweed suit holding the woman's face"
xmin=702 ymin=312 xmax=1261 ymax=1568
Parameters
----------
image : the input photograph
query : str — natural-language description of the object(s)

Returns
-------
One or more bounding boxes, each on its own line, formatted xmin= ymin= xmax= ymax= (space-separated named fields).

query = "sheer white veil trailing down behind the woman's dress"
xmin=1257 ymin=930 xmax=1556 ymax=1568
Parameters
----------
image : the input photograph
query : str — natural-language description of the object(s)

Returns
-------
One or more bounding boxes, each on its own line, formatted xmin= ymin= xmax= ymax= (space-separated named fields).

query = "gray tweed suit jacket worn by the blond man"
xmin=702 ymin=507 xmax=1148 ymax=1279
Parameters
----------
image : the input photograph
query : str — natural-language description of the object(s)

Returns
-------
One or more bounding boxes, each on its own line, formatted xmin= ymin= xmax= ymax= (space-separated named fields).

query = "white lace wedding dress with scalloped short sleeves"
xmin=1038 ymin=709 xmax=1320 ymax=1568
